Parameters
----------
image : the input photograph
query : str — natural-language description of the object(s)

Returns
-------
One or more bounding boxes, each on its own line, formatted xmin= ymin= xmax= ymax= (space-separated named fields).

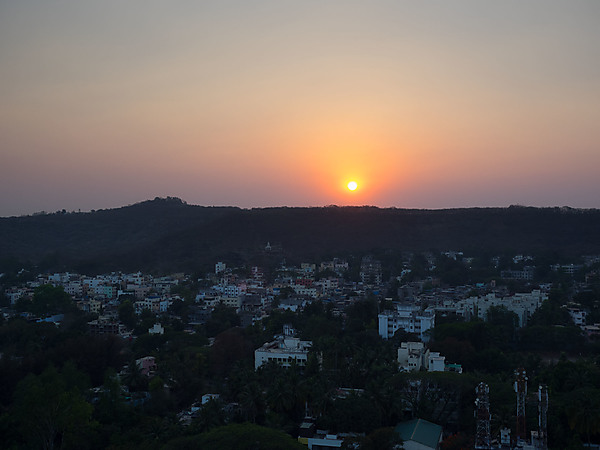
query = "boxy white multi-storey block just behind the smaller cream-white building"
xmin=378 ymin=303 xmax=435 ymax=342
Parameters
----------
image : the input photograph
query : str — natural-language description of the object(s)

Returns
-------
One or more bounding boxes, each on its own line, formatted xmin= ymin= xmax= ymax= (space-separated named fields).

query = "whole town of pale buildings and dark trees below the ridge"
xmin=0 ymin=248 xmax=600 ymax=449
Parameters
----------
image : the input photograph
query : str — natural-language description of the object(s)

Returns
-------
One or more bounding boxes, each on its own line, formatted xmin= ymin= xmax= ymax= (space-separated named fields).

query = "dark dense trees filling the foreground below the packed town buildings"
xmin=0 ymin=292 xmax=600 ymax=449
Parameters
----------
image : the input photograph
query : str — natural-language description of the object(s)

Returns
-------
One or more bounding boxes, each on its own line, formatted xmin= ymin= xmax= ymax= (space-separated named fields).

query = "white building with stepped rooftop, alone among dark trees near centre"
xmin=254 ymin=327 xmax=312 ymax=369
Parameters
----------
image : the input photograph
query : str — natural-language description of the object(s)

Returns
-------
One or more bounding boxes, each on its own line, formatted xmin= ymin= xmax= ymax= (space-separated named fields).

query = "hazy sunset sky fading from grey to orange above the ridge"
xmin=0 ymin=0 xmax=600 ymax=216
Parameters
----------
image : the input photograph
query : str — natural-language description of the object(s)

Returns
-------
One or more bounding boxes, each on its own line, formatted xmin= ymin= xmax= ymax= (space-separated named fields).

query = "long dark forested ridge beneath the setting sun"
xmin=0 ymin=197 xmax=600 ymax=273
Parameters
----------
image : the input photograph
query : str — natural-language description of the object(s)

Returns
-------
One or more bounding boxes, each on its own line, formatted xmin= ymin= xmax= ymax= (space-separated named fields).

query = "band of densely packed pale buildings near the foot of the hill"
xmin=5 ymin=250 xmax=600 ymax=347
